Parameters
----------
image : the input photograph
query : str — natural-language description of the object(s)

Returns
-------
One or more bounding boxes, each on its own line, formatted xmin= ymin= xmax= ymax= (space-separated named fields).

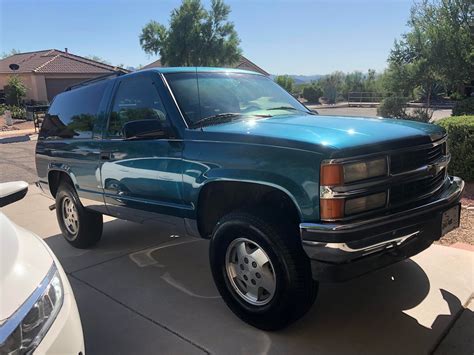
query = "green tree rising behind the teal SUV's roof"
xmin=139 ymin=0 xmax=241 ymax=66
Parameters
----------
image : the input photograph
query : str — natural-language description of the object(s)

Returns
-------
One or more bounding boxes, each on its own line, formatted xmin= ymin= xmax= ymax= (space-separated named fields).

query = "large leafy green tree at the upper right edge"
xmin=386 ymin=0 xmax=474 ymax=105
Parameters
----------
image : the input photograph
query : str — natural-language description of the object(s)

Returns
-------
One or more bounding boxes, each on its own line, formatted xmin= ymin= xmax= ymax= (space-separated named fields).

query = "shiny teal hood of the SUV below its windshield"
xmin=203 ymin=115 xmax=444 ymax=149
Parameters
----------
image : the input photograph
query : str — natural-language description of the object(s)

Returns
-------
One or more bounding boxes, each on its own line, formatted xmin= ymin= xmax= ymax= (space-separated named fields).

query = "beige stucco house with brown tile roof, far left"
xmin=0 ymin=48 xmax=126 ymax=102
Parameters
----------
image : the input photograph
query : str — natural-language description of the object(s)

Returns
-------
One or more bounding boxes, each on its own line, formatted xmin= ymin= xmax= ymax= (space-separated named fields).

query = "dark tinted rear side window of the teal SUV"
xmin=40 ymin=81 xmax=108 ymax=138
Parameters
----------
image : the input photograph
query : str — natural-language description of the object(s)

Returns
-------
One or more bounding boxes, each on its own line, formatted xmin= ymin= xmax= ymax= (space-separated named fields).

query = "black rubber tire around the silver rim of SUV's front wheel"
xmin=209 ymin=212 xmax=318 ymax=330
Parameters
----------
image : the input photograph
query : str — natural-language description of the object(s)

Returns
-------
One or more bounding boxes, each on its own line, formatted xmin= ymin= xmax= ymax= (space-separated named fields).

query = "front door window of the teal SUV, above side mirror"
xmin=107 ymin=76 xmax=168 ymax=137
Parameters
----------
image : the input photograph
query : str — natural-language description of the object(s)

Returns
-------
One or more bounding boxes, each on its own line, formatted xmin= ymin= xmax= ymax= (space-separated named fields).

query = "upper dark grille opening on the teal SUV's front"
xmin=390 ymin=143 xmax=446 ymax=174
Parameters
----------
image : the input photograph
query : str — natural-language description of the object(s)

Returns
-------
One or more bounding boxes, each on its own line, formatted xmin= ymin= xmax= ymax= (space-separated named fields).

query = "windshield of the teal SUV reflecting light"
xmin=166 ymin=72 xmax=312 ymax=126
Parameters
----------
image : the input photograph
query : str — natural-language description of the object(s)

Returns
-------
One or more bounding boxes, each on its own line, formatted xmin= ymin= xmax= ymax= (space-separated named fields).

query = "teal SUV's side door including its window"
xmin=100 ymin=73 xmax=184 ymax=223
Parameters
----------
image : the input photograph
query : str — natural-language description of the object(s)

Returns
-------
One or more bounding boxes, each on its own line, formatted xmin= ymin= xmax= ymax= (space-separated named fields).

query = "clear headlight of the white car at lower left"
xmin=0 ymin=264 xmax=64 ymax=355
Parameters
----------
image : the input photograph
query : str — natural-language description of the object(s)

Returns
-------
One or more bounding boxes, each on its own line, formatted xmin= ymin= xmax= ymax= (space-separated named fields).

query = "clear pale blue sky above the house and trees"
xmin=0 ymin=0 xmax=412 ymax=75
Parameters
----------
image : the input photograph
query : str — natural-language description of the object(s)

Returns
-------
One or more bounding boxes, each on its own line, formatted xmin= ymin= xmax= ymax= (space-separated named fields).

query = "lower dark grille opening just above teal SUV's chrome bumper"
xmin=390 ymin=169 xmax=446 ymax=206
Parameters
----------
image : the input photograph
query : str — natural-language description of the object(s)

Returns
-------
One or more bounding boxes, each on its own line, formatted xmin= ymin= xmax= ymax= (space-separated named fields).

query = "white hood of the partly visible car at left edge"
xmin=0 ymin=212 xmax=53 ymax=324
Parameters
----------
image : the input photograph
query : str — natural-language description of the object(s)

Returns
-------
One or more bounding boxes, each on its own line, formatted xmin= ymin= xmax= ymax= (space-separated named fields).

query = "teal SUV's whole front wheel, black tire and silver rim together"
xmin=209 ymin=212 xmax=318 ymax=330
